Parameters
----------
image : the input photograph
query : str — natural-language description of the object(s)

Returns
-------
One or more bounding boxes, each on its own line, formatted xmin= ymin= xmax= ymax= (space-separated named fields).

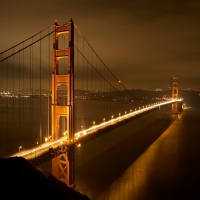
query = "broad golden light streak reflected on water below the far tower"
xmin=97 ymin=114 xmax=180 ymax=200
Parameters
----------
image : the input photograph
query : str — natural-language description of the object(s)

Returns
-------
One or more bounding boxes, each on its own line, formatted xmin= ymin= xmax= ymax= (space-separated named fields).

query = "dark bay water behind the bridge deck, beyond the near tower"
xmin=0 ymin=97 xmax=135 ymax=157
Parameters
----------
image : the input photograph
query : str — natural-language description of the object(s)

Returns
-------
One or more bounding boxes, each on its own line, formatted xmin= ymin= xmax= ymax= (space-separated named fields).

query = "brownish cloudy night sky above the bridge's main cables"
xmin=0 ymin=0 xmax=200 ymax=89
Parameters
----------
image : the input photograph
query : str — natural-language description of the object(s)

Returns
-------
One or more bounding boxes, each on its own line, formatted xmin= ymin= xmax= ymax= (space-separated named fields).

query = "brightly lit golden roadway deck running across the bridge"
xmin=11 ymin=99 xmax=182 ymax=165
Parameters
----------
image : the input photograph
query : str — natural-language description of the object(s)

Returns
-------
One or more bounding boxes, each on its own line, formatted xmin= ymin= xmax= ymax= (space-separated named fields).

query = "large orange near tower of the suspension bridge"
xmin=51 ymin=20 xmax=75 ymax=186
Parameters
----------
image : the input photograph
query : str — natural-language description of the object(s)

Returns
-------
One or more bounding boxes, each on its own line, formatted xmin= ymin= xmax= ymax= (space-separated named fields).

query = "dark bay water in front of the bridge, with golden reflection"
xmin=76 ymin=96 xmax=200 ymax=200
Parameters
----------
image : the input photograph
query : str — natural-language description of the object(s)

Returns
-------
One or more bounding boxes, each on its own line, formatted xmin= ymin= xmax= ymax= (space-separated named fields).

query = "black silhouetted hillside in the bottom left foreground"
xmin=0 ymin=157 xmax=89 ymax=200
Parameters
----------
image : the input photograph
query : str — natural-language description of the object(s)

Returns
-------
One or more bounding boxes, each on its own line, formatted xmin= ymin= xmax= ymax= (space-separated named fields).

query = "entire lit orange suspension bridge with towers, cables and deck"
xmin=0 ymin=20 xmax=182 ymax=188
